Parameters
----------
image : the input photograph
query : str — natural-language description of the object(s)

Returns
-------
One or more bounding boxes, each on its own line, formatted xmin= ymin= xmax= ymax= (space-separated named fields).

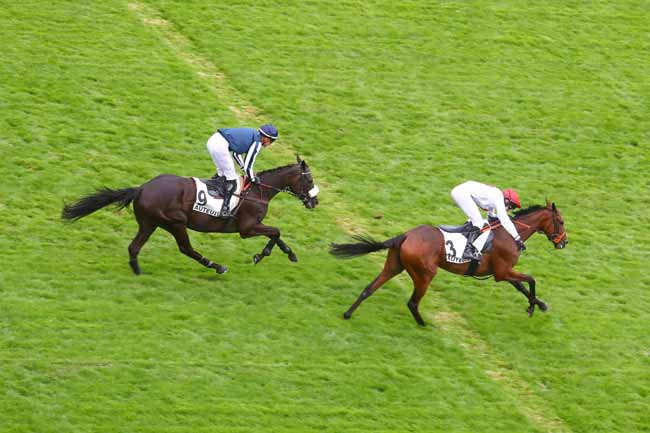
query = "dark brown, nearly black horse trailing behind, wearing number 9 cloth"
xmin=61 ymin=156 xmax=318 ymax=275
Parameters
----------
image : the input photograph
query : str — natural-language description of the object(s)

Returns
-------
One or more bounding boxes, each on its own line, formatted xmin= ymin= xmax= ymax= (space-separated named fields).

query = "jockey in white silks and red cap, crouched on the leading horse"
xmin=451 ymin=180 xmax=526 ymax=260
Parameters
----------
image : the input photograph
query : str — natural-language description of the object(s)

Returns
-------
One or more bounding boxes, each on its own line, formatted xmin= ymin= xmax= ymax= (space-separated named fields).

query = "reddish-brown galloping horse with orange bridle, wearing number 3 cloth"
xmin=330 ymin=201 xmax=568 ymax=326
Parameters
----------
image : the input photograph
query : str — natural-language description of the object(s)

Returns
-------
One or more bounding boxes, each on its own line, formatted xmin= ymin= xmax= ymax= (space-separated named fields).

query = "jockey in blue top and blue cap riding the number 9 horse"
xmin=207 ymin=124 xmax=278 ymax=217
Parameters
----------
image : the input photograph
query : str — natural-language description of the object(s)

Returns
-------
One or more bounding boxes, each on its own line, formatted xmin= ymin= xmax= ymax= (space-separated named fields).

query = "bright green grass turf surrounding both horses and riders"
xmin=0 ymin=0 xmax=650 ymax=433
